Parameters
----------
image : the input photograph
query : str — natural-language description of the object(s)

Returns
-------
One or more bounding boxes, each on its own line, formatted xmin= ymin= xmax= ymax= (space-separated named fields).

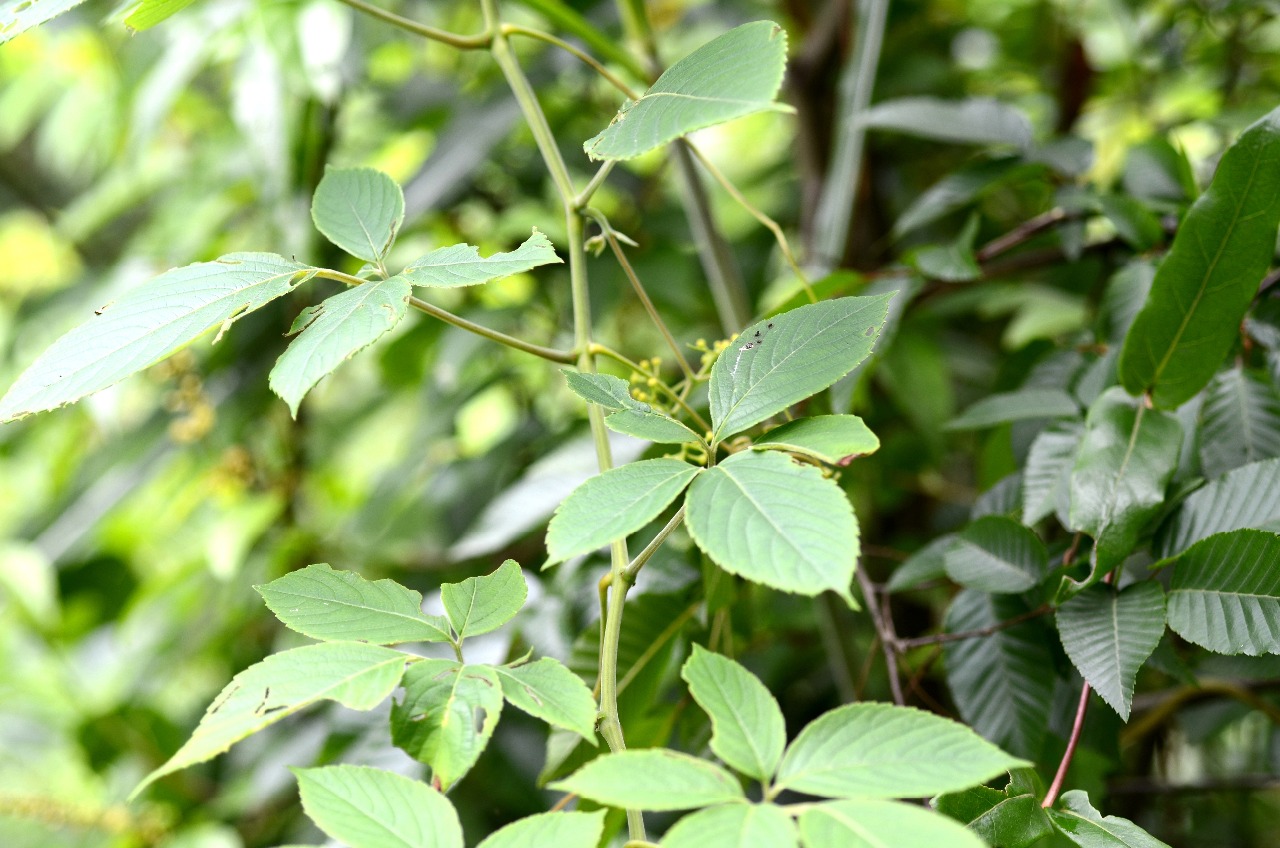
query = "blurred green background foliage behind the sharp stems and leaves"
xmin=0 ymin=0 xmax=1280 ymax=848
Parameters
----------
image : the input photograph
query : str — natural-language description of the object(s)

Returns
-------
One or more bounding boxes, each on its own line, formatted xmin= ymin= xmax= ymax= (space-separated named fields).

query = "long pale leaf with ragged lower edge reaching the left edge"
xmin=0 ymin=254 xmax=315 ymax=423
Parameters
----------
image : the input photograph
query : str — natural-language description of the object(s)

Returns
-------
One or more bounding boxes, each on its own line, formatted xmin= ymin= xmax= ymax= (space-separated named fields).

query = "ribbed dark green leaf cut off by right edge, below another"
xmin=1169 ymin=530 xmax=1280 ymax=657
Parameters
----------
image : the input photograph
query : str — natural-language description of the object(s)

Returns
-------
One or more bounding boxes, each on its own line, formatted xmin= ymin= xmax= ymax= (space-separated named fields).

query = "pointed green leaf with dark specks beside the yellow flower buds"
xmin=709 ymin=295 xmax=893 ymax=442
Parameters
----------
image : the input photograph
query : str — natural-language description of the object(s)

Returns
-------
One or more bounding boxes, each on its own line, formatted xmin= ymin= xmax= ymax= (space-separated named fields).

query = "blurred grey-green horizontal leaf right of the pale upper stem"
xmin=861 ymin=97 xmax=1032 ymax=149
